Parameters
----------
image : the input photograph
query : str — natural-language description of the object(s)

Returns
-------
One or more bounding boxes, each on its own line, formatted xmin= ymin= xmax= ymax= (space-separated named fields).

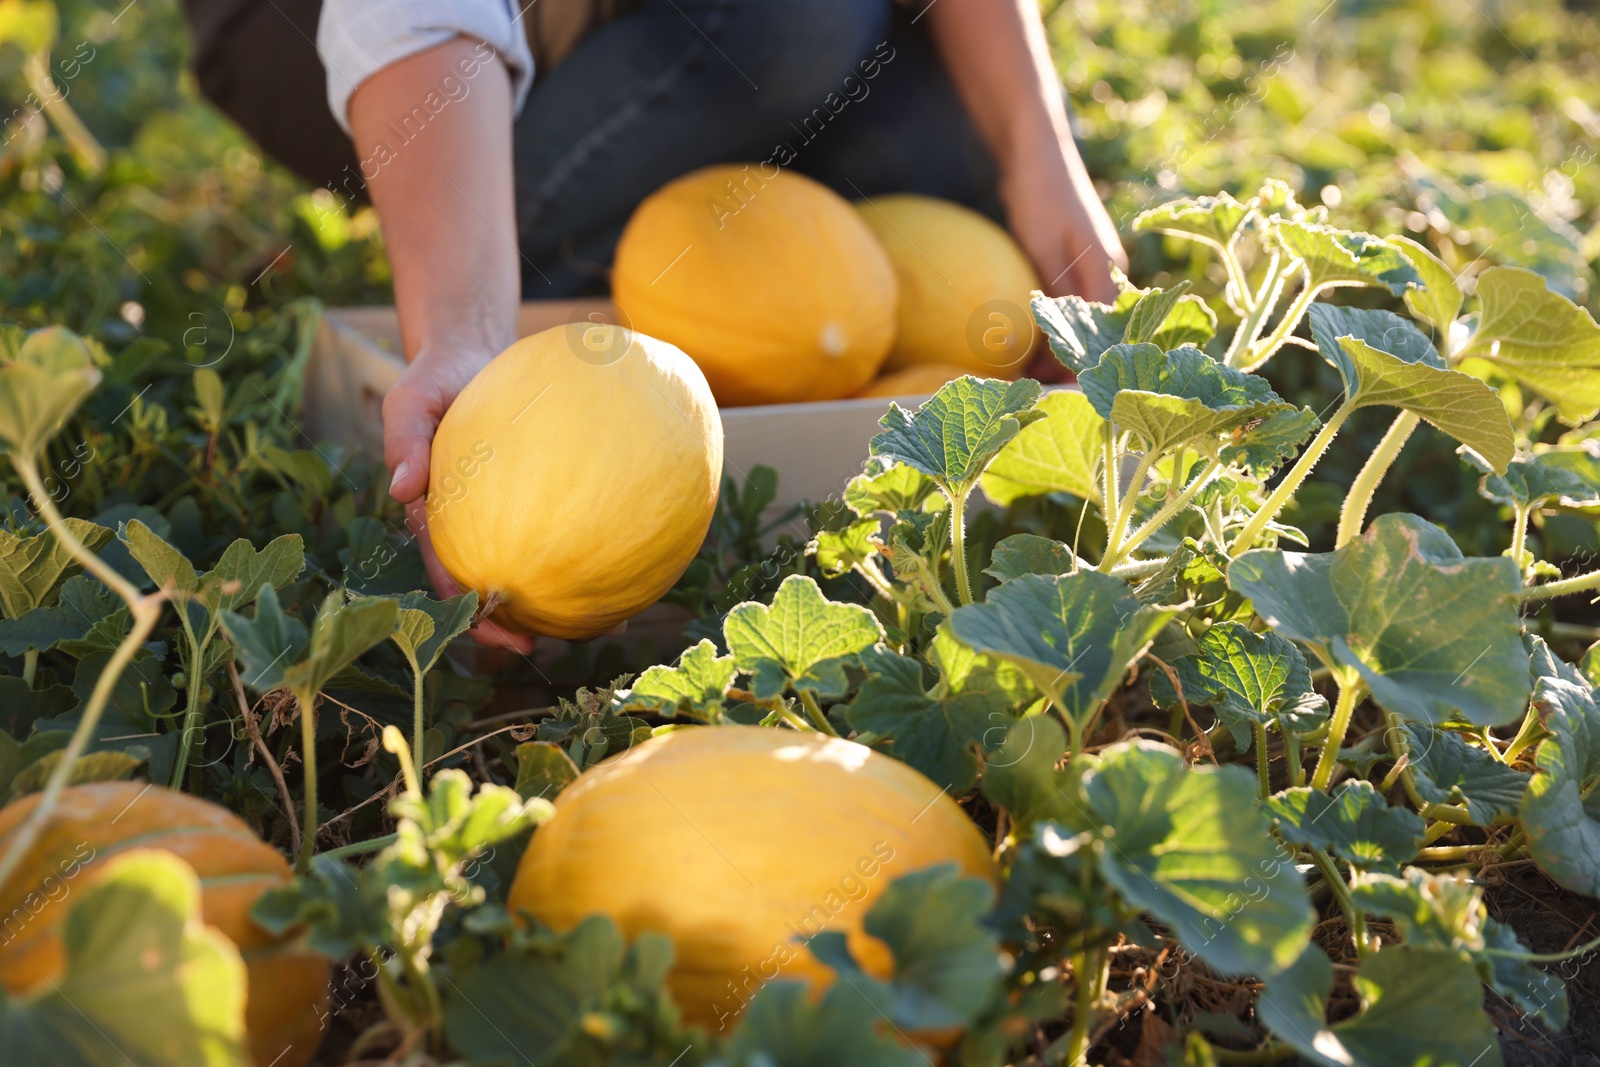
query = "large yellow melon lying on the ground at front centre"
xmin=509 ymin=726 xmax=997 ymax=1027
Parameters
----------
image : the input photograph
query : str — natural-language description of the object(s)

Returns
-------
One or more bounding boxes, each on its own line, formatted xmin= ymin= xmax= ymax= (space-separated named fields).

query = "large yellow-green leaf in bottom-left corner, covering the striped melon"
xmin=0 ymin=851 xmax=246 ymax=1067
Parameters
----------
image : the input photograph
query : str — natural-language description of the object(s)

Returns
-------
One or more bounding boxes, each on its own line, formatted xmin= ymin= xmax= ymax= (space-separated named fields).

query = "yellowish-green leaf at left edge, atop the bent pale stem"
xmin=0 ymin=326 xmax=101 ymax=458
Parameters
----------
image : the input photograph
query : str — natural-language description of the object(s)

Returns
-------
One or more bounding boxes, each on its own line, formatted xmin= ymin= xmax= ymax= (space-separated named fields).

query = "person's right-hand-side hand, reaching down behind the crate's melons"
xmin=1000 ymin=134 xmax=1128 ymax=304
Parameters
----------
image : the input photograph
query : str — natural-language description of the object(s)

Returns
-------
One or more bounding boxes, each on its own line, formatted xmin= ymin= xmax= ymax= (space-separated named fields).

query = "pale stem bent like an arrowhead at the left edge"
xmin=0 ymin=453 xmax=163 ymax=885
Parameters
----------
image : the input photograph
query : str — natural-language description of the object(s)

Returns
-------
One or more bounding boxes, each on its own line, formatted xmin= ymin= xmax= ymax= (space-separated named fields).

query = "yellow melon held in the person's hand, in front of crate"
xmin=427 ymin=322 xmax=722 ymax=640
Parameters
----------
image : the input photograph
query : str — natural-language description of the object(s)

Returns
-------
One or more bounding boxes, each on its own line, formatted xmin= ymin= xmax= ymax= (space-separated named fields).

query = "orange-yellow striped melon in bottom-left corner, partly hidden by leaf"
xmin=0 ymin=782 xmax=328 ymax=1067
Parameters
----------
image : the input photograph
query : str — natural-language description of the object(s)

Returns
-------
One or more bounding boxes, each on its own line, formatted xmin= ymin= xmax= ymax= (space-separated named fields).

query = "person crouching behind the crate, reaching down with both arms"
xmin=186 ymin=0 xmax=1123 ymax=649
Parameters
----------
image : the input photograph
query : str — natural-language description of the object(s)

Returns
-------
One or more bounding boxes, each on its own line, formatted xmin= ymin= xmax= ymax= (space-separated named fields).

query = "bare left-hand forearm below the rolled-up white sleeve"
xmin=349 ymin=37 xmax=520 ymax=360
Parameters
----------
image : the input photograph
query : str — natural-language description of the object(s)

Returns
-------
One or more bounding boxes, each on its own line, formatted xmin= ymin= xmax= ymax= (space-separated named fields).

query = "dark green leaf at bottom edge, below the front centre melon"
xmin=712 ymin=981 xmax=928 ymax=1067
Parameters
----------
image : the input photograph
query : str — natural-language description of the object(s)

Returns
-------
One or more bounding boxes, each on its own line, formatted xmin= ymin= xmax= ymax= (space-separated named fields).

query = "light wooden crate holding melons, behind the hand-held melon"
xmin=306 ymin=301 xmax=923 ymax=661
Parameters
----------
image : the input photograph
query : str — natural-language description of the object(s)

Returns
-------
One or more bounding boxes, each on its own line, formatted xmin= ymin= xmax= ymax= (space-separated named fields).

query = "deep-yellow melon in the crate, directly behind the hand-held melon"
xmin=611 ymin=165 xmax=894 ymax=405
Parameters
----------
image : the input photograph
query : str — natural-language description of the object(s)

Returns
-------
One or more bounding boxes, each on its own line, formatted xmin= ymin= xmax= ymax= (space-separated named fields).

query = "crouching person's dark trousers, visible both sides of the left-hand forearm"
xmin=184 ymin=0 xmax=1000 ymax=299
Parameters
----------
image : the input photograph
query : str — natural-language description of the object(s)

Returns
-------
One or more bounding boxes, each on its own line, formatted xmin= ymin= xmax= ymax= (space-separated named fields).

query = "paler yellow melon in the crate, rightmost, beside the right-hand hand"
xmin=856 ymin=194 xmax=1040 ymax=378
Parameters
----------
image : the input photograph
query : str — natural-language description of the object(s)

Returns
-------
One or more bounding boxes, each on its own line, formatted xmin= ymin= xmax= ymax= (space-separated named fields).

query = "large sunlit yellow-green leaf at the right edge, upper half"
xmin=1456 ymin=267 xmax=1600 ymax=426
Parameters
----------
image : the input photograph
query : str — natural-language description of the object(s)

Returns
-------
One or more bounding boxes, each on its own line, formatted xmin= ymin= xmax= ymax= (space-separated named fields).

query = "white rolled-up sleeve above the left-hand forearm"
xmin=317 ymin=0 xmax=533 ymax=133
